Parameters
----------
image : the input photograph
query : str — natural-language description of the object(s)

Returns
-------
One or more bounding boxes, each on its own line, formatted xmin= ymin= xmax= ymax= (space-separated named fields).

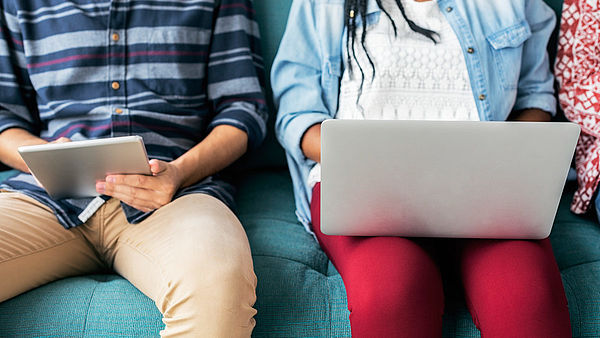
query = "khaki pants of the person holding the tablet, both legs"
xmin=0 ymin=193 xmax=256 ymax=337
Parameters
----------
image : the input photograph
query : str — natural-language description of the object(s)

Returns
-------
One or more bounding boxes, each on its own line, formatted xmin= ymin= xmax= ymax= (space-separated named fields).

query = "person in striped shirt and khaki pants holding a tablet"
xmin=0 ymin=0 xmax=267 ymax=337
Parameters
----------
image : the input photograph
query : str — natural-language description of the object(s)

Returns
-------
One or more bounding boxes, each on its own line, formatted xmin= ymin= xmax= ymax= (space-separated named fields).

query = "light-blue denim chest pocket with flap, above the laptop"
xmin=486 ymin=21 xmax=531 ymax=90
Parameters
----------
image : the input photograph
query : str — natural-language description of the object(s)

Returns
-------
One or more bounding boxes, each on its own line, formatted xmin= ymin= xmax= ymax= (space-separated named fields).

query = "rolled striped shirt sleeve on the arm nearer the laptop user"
xmin=207 ymin=0 xmax=268 ymax=149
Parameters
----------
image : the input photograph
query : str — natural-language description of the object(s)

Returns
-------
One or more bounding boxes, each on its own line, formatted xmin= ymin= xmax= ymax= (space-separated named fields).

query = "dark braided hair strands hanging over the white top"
xmin=344 ymin=0 xmax=439 ymax=92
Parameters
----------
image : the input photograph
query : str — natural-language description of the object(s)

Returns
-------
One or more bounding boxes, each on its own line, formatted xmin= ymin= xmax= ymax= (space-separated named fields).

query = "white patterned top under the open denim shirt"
xmin=308 ymin=0 xmax=479 ymax=187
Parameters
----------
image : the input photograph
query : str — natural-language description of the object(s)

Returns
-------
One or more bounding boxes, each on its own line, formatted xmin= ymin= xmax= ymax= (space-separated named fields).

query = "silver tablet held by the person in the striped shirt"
xmin=18 ymin=136 xmax=152 ymax=199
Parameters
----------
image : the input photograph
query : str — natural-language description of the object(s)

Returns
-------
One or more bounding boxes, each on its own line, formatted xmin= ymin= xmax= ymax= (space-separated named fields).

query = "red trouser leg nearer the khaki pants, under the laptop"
xmin=311 ymin=184 xmax=444 ymax=338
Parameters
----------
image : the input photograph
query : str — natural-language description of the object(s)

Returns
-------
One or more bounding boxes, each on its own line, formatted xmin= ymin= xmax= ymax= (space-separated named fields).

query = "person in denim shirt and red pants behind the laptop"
xmin=271 ymin=0 xmax=570 ymax=337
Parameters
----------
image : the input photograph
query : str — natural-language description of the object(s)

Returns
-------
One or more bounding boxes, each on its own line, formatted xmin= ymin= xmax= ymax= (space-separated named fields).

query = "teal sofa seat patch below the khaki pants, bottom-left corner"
xmin=0 ymin=275 xmax=164 ymax=337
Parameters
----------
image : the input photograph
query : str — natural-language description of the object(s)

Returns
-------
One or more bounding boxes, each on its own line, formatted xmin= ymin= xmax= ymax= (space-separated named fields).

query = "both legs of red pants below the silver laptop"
xmin=311 ymin=184 xmax=571 ymax=338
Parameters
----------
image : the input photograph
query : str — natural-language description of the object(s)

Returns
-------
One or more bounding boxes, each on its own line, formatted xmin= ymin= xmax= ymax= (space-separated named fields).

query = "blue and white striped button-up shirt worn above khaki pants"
xmin=0 ymin=0 xmax=267 ymax=228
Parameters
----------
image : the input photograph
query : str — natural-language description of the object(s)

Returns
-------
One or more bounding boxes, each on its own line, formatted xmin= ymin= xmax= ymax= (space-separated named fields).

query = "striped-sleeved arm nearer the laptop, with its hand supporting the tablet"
xmin=96 ymin=0 xmax=267 ymax=212
